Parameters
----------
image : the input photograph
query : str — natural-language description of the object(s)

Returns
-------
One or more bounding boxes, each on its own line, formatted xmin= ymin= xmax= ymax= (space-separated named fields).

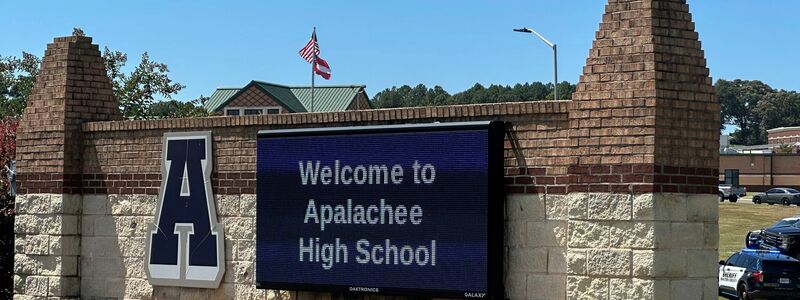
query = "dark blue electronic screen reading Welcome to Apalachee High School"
xmin=256 ymin=129 xmax=489 ymax=292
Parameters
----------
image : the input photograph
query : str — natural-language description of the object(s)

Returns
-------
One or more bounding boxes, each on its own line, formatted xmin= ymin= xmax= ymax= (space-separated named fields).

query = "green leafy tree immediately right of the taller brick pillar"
xmin=714 ymin=79 xmax=775 ymax=145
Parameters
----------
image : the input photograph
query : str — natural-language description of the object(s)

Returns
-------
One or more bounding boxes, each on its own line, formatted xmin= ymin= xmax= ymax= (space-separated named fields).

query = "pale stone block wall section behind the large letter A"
xmin=80 ymin=194 xmax=265 ymax=299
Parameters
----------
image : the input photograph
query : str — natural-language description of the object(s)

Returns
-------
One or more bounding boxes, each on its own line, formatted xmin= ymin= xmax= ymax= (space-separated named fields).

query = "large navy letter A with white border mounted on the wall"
xmin=144 ymin=131 xmax=225 ymax=288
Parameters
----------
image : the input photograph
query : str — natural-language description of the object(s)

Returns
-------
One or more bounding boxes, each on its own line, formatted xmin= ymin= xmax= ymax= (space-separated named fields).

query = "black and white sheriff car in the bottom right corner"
xmin=719 ymin=249 xmax=800 ymax=300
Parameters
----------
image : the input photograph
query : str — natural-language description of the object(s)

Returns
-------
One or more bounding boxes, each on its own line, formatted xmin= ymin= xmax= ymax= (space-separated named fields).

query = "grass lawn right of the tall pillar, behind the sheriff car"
xmin=719 ymin=200 xmax=800 ymax=259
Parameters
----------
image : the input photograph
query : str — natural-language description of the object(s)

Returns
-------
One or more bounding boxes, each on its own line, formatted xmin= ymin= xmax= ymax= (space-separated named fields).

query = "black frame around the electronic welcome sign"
xmin=255 ymin=121 xmax=506 ymax=300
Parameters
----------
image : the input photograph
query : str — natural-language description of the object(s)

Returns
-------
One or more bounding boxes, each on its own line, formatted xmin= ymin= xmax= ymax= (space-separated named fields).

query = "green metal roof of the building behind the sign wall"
xmin=205 ymin=81 xmax=365 ymax=112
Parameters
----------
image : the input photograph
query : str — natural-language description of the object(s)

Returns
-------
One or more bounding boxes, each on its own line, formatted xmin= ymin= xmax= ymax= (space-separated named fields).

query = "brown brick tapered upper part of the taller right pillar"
xmin=570 ymin=0 xmax=720 ymax=193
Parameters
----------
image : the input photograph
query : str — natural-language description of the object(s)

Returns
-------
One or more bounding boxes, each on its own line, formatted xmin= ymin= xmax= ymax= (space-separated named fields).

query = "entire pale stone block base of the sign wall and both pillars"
xmin=14 ymin=193 xmax=719 ymax=300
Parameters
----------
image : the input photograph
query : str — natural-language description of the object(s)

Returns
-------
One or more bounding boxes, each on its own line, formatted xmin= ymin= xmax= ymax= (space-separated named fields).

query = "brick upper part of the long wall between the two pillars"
xmin=18 ymin=101 xmax=569 ymax=194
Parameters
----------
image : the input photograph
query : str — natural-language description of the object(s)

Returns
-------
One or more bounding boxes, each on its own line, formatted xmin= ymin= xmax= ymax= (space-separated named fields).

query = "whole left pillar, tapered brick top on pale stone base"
xmin=14 ymin=36 xmax=121 ymax=298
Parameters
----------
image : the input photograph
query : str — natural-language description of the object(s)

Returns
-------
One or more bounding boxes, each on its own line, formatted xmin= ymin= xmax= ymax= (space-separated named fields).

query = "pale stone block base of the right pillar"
xmin=567 ymin=194 xmax=719 ymax=300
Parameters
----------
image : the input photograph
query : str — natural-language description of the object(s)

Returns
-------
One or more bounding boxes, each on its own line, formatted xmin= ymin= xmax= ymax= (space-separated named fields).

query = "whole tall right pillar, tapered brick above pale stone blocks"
xmin=567 ymin=0 xmax=720 ymax=299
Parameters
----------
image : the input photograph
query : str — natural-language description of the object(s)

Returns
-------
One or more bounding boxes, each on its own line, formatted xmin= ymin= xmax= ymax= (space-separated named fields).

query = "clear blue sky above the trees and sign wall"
xmin=0 ymin=0 xmax=800 ymax=100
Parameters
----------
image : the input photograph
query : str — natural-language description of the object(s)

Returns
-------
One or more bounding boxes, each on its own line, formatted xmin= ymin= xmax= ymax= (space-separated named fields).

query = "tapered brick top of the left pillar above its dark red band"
xmin=17 ymin=36 xmax=122 ymax=174
